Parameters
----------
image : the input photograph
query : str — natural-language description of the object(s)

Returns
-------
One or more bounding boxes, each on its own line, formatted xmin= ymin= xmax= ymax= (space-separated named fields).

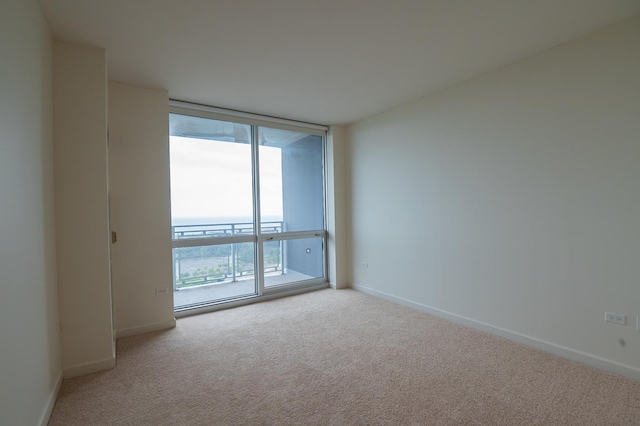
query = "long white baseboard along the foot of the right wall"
xmin=351 ymin=285 xmax=640 ymax=381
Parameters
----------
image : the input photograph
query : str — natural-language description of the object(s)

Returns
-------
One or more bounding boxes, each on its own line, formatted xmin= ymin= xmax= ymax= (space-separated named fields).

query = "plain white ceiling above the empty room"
xmin=40 ymin=0 xmax=640 ymax=124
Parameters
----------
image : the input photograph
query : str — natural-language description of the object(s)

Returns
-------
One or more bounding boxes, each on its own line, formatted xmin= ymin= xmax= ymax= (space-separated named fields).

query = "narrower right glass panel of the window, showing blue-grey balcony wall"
xmin=258 ymin=127 xmax=324 ymax=287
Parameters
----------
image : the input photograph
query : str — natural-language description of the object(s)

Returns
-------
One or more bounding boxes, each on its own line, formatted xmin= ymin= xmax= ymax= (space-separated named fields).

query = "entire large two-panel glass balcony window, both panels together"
xmin=170 ymin=108 xmax=326 ymax=310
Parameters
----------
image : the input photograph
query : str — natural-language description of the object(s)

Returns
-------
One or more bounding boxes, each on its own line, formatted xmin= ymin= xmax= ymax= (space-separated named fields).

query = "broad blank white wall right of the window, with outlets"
xmin=348 ymin=18 xmax=640 ymax=378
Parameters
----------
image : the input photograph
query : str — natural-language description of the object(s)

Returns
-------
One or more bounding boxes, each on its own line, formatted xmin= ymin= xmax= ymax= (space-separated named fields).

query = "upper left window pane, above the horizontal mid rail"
xmin=169 ymin=114 xmax=253 ymax=225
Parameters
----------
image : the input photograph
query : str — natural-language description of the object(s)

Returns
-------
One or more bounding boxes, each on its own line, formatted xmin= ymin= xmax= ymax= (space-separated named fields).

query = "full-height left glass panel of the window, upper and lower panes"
xmin=169 ymin=114 xmax=257 ymax=308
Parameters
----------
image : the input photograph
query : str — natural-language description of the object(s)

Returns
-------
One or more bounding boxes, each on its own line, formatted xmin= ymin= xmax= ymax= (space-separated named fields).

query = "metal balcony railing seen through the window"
xmin=171 ymin=221 xmax=284 ymax=291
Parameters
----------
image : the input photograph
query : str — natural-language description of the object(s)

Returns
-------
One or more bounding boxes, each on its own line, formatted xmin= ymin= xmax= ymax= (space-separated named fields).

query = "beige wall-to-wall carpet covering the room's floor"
xmin=49 ymin=290 xmax=640 ymax=426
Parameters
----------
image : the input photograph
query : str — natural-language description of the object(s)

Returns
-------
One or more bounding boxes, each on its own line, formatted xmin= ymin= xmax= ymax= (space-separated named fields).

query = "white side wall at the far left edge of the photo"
xmin=0 ymin=0 xmax=61 ymax=426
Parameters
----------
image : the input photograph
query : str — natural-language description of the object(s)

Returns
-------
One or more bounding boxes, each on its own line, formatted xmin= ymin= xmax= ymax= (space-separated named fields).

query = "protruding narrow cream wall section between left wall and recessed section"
xmin=53 ymin=42 xmax=115 ymax=377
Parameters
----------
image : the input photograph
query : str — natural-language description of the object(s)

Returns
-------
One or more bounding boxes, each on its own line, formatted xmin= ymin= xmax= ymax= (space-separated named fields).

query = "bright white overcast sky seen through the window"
xmin=170 ymin=136 xmax=282 ymax=219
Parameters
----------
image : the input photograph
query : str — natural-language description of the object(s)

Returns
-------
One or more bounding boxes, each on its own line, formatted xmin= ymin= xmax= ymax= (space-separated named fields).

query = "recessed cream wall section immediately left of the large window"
xmin=109 ymin=82 xmax=175 ymax=337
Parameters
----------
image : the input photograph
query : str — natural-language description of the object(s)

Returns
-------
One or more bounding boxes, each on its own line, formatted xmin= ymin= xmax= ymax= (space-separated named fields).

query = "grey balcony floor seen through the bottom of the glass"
xmin=173 ymin=271 xmax=315 ymax=308
